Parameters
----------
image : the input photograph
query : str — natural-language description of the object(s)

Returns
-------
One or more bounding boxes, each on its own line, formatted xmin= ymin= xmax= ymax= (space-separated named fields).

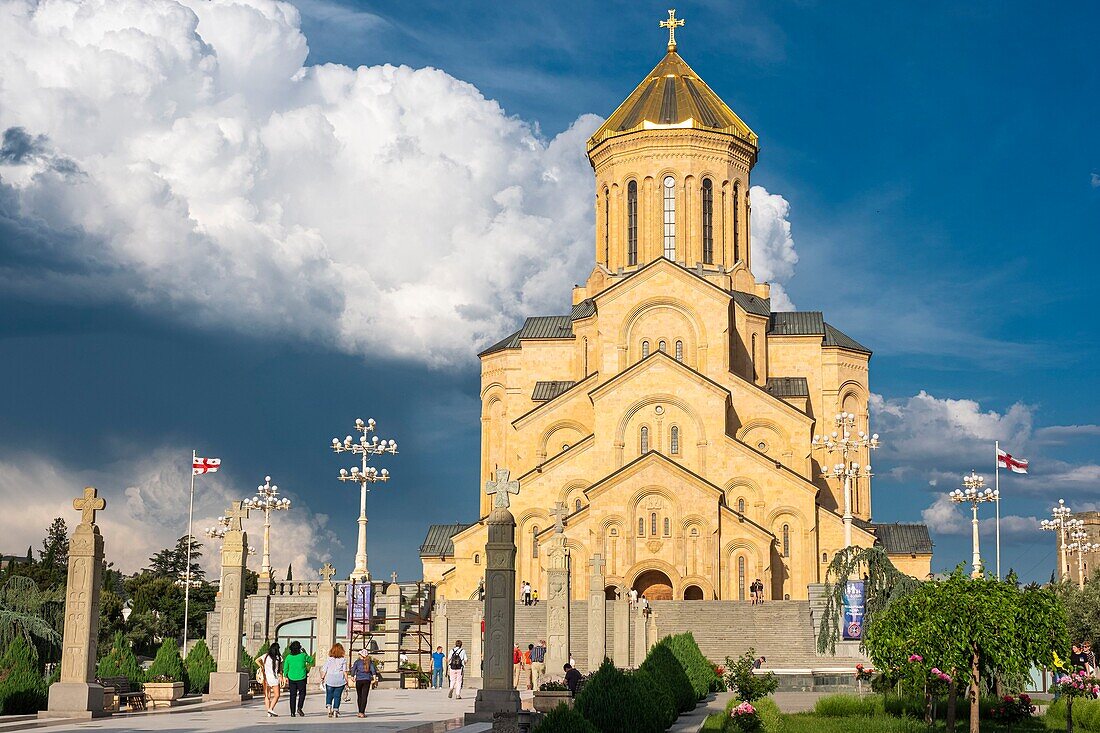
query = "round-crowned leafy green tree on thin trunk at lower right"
xmin=865 ymin=568 xmax=1069 ymax=733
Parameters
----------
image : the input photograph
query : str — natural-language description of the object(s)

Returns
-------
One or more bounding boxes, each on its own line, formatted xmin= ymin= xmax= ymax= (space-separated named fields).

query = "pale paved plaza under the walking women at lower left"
xmin=0 ymin=689 xmax=484 ymax=733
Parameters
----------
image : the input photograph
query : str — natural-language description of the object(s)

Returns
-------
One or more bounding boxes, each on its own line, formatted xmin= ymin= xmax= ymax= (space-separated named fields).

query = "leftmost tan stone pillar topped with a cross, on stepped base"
xmin=39 ymin=486 xmax=110 ymax=718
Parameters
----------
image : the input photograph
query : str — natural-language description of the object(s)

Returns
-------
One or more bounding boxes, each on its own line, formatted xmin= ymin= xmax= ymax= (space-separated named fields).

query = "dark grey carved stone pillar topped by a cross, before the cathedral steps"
xmin=466 ymin=469 xmax=519 ymax=724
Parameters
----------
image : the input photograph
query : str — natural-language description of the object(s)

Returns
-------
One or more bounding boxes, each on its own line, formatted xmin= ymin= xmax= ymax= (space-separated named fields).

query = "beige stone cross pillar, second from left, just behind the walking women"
xmin=207 ymin=502 xmax=252 ymax=702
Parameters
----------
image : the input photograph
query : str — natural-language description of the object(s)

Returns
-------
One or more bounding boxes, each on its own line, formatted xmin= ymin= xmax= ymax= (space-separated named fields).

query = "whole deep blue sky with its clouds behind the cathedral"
xmin=0 ymin=0 xmax=1100 ymax=579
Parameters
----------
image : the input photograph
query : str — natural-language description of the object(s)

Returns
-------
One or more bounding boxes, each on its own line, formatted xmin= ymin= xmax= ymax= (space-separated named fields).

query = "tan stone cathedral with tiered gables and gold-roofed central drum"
xmin=420 ymin=21 xmax=932 ymax=600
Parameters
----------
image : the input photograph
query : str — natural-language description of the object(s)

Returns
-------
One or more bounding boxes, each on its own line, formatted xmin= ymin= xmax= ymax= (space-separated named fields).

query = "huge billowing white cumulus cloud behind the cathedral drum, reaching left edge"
xmin=0 ymin=0 xmax=798 ymax=367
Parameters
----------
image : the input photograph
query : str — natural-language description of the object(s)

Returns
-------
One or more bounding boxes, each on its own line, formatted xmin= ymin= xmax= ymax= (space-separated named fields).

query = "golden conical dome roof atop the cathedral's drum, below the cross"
xmin=589 ymin=49 xmax=757 ymax=152
